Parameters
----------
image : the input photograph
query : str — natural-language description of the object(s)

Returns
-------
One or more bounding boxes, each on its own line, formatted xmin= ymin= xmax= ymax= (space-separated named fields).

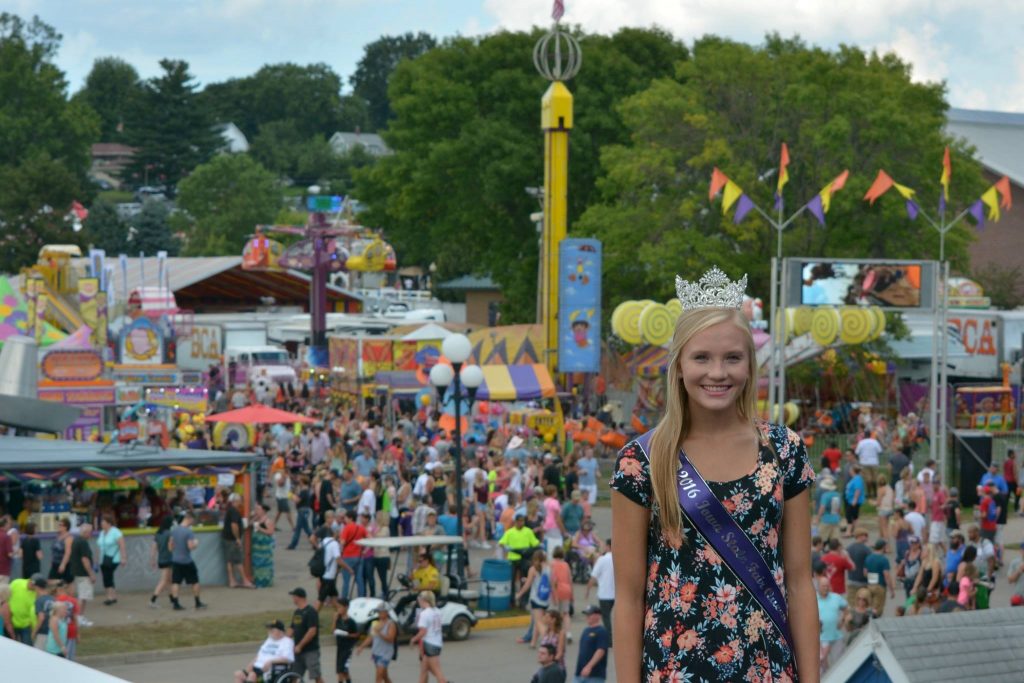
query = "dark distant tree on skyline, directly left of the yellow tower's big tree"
xmin=348 ymin=32 xmax=437 ymax=130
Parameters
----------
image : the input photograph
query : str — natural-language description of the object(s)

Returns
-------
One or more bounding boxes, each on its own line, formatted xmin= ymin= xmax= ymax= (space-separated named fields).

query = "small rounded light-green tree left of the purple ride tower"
xmin=172 ymin=155 xmax=282 ymax=256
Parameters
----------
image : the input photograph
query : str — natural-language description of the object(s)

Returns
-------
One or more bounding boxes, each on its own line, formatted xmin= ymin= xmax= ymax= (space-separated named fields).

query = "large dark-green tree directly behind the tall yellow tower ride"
xmin=355 ymin=29 xmax=687 ymax=322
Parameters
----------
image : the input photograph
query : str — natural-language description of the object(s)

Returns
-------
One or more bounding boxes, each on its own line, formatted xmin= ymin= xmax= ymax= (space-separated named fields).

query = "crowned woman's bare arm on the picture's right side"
xmin=778 ymin=488 xmax=820 ymax=683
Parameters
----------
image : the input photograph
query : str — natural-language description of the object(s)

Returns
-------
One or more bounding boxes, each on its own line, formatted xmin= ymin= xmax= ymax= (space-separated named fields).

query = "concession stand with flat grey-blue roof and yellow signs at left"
xmin=0 ymin=436 xmax=258 ymax=591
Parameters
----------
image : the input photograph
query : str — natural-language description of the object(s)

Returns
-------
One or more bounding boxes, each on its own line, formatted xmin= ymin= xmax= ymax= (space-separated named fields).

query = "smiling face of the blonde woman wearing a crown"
xmin=679 ymin=322 xmax=751 ymax=413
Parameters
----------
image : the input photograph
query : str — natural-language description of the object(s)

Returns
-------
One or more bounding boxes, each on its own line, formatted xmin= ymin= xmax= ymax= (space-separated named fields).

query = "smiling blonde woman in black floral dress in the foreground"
xmin=611 ymin=271 xmax=819 ymax=683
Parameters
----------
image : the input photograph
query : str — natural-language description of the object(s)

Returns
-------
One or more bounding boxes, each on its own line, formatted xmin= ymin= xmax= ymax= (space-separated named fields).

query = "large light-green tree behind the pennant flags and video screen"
xmin=572 ymin=36 xmax=983 ymax=310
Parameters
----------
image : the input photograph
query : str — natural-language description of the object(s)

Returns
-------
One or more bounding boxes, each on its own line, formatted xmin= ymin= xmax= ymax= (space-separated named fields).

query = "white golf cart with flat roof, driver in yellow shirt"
xmin=348 ymin=536 xmax=479 ymax=640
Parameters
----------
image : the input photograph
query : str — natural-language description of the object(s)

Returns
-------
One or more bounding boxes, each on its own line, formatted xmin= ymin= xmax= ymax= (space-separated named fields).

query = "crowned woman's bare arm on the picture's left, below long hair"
xmin=611 ymin=490 xmax=647 ymax=683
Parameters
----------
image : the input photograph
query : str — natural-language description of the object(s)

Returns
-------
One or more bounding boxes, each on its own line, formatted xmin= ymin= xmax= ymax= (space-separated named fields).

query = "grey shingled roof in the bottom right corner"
xmin=824 ymin=607 xmax=1024 ymax=683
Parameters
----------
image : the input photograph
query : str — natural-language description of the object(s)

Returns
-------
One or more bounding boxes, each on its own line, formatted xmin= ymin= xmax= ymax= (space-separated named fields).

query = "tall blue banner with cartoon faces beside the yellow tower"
xmin=558 ymin=239 xmax=601 ymax=373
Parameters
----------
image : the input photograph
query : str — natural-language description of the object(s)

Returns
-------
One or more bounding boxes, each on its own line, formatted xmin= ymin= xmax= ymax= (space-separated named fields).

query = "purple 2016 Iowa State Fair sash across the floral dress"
xmin=636 ymin=431 xmax=793 ymax=649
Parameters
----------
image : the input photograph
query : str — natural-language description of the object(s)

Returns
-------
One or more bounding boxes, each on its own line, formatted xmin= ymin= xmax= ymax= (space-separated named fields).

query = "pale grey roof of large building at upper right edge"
xmin=946 ymin=109 xmax=1024 ymax=185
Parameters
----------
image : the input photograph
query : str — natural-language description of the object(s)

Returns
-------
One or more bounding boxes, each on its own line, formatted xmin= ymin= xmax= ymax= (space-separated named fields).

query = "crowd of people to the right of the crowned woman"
xmin=812 ymin=430 xmax=1024 ymax=671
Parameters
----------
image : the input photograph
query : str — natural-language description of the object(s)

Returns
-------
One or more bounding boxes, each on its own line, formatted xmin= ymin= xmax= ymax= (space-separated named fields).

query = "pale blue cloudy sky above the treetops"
xmin=14 ymin=0 xmax=1024 ymax=112
